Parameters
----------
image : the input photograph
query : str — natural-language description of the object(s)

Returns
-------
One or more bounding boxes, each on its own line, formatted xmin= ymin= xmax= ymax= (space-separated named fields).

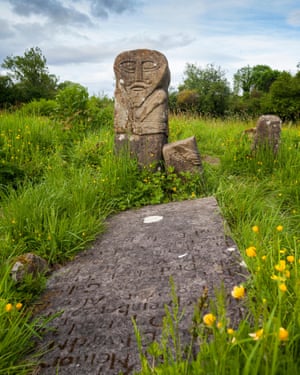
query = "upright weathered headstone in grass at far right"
xmin=252 ymin=115 xmax=282 ymax=153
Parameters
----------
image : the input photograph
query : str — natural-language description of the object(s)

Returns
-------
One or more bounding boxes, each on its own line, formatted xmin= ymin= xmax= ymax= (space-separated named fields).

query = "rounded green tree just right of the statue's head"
xmin=179 ymin=64 xmax=230 ymax=116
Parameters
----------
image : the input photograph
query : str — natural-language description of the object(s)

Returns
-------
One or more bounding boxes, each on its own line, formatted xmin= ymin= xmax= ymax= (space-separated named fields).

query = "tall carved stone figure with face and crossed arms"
xmin=114 ymin=49 xmax=170 ymax=166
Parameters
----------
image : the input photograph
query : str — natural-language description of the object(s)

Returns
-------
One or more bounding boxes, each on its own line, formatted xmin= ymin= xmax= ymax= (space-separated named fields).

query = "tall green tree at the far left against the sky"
xmin=1 ymin=47 xmax=58 ymax=102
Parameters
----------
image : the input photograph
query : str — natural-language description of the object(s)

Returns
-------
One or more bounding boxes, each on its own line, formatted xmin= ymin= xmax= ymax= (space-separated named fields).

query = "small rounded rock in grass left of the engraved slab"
xmin=10 ymin=253 xmax=48 ymax=282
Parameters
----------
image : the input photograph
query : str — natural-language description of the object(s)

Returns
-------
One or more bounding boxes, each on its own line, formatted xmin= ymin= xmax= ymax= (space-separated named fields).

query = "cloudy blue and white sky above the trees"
xmin=0 ymin=0 xmax=300 ymax=96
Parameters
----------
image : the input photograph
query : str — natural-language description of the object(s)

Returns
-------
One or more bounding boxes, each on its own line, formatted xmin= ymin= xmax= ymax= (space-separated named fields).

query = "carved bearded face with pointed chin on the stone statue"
xmin=114 ymin=49 xmax=170 ymax=105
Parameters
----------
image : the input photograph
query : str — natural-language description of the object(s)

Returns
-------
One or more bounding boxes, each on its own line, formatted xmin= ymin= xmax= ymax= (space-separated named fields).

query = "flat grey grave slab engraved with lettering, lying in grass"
xmin=34 ymin=197 xmax=245 ymax=375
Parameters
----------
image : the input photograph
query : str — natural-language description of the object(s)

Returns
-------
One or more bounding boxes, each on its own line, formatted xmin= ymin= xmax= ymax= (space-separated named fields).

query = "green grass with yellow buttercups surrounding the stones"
xmin=0 ymin=113 xmax=300 ymax=375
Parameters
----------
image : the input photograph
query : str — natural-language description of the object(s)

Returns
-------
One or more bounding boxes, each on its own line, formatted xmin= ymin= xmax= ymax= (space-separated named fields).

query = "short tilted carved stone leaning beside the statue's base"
xmin=163 ymin=136 xmax=202 ymax=173
